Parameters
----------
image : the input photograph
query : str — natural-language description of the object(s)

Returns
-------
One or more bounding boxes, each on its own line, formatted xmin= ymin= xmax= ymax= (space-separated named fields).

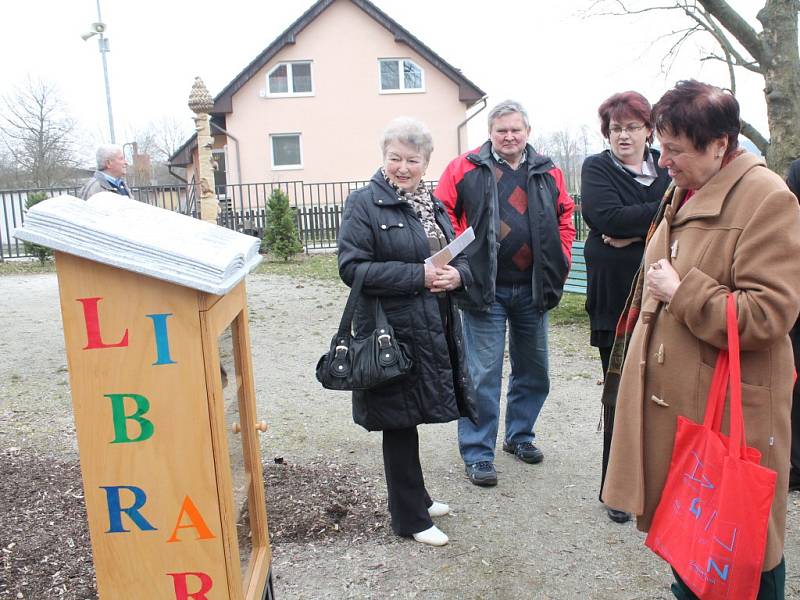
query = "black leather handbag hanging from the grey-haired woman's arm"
xmin=317 ymin=265 xmax=412 ymax=390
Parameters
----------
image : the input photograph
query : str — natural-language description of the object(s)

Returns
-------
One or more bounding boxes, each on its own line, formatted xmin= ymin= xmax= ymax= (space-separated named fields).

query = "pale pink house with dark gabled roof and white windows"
xmin=170 ymin=0 xmax=486 ymax=192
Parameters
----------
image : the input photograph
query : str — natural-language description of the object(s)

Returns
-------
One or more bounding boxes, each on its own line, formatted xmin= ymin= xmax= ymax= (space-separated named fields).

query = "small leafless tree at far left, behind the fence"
xmin=0 ymin=79 xmax=77 ymax=187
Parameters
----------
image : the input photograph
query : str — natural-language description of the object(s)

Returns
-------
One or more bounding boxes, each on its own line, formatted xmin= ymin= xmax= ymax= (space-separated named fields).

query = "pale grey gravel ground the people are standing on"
xmin=0 ymin=274 xmax=800 ymax=600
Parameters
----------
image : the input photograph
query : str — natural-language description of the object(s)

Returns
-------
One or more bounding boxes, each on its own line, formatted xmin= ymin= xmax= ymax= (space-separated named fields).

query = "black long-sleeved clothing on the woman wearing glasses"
xmin=581 ymin=150 xmax=670 ymax=338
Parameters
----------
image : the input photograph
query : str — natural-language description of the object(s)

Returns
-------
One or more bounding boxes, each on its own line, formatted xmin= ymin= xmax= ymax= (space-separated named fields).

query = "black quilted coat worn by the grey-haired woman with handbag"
xmin=338 ymin=171 xmax=476 ymax=431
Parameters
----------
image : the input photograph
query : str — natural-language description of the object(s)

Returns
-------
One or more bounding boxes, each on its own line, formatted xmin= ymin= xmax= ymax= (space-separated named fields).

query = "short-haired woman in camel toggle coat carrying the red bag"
xmin=603 ymin=81 xmax=800 ymax=598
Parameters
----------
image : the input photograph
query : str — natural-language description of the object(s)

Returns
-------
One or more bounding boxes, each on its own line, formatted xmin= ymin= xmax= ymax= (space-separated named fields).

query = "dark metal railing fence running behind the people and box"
xmin=0 ymin=181 xmax=587 ymax=261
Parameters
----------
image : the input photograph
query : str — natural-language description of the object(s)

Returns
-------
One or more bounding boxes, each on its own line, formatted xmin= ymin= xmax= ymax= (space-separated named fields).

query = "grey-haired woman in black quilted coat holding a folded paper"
xmin=339 ymin=118 xmax=475 ymax=546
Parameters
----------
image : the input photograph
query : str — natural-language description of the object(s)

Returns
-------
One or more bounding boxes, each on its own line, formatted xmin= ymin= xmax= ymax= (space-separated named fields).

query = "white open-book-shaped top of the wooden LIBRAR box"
xmin=14 ymin=192 xmax=261 ymax=295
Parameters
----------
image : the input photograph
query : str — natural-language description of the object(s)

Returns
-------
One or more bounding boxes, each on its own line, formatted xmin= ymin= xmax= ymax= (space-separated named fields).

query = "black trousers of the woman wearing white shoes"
xmin=383 ymin=427 xmax=433 ymax=536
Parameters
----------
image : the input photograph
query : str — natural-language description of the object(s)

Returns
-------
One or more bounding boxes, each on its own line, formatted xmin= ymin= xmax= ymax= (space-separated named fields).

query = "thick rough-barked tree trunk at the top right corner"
xmin=758 ymin=0 xmax=800 ymax=176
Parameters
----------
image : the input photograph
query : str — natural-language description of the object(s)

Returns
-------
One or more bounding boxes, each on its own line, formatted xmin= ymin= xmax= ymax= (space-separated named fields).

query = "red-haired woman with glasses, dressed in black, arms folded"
xmin=581 ymin=92 xmax=669 ymax=523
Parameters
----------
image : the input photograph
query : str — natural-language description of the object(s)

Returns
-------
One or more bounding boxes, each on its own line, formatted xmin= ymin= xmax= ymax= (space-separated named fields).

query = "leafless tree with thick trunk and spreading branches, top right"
xmin=594 ymin=0 xmax=800 ymax=173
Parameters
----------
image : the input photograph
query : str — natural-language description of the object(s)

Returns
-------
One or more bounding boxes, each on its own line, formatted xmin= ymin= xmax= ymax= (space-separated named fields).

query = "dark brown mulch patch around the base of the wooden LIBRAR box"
xmin=0 ymin=448 xmax=394 ymax=599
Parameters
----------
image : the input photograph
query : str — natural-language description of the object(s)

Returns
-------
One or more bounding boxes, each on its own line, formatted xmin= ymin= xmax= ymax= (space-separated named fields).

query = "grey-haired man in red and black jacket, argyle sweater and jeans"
xmin=435 ymin=100 xmax=575 ymax=486
